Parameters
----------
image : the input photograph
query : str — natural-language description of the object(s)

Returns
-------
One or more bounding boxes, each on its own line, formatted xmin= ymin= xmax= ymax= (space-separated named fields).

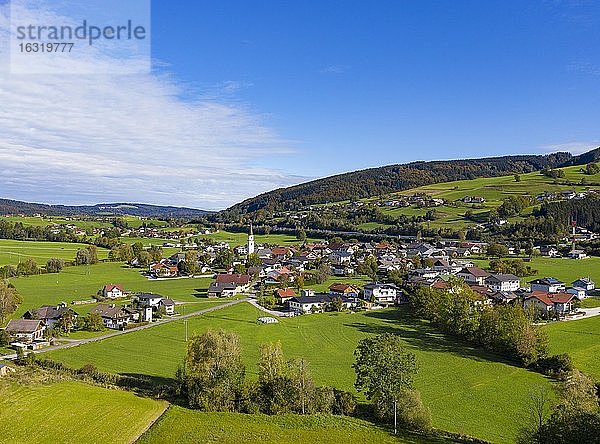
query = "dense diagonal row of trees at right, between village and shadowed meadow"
xmin=410 ymin=280 xmax=548 ymax=366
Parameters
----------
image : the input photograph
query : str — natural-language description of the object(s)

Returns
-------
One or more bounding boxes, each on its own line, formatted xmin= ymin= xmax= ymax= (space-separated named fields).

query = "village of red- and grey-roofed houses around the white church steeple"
xmin=5 ymin=227 xmax=598 ymax=350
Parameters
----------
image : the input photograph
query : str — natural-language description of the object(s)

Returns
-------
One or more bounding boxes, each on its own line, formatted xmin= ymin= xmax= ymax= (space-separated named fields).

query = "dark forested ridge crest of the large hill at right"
xmin=219 ymin=148 xmax=600 ymax=219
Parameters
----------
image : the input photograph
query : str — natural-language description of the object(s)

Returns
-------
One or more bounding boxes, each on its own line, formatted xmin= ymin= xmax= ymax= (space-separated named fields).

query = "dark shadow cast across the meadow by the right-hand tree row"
xmin=344 ymin=307 xmax=518 ymax=367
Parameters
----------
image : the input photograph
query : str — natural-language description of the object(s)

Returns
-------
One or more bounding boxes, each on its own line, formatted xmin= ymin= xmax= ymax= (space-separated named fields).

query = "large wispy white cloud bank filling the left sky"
xmin=0 ymin=0 xmax=304 ymax=209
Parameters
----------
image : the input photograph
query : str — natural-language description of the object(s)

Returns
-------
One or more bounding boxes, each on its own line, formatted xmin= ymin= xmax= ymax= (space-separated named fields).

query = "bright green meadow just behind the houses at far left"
xmin=11 ymin=262 xmax=218 ymax=316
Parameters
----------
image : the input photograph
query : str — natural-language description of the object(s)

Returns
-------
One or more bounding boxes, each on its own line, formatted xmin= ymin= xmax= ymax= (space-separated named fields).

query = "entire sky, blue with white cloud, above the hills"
xmin=0 ymin=0 xmax=600 ymax=209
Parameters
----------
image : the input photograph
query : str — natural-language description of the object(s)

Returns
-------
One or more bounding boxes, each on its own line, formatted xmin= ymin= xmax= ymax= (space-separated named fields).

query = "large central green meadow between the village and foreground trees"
xmin=48 ymin=304 xmax=549 ymax=442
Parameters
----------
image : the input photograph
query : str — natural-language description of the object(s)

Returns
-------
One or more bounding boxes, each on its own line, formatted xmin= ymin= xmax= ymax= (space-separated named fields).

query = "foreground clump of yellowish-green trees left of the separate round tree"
xmin=176 ymin=330 xmax=356 ymax=415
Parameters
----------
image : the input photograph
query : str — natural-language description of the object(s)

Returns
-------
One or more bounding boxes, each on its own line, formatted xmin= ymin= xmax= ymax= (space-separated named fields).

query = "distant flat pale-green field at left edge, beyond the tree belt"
xmin=0 ymin=239 xmax=108 ymax=266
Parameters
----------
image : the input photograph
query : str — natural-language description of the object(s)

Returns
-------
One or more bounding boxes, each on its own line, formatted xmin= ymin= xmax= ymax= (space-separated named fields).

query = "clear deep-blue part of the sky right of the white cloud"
xmin=153 ymin=0 xmax=600 ymax=176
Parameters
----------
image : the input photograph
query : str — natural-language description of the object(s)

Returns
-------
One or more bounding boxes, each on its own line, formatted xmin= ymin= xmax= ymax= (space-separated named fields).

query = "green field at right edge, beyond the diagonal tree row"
xmin=544 ymin=316 xmax=600 ymax=382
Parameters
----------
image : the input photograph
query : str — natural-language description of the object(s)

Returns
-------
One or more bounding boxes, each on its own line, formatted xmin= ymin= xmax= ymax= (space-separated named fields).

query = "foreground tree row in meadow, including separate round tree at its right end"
xmin=176 ymin=330 xmax=431 ymax=430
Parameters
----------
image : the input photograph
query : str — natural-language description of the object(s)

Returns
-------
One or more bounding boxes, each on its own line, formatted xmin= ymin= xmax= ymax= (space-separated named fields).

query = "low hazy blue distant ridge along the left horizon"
xmin=0 ymin=199 xmax=210 ymax=218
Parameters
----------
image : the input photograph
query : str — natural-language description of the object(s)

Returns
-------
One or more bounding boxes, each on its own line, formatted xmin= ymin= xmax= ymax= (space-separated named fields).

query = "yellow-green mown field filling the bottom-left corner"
xmin=0 ymin=381 xmax=166 ymax=444
